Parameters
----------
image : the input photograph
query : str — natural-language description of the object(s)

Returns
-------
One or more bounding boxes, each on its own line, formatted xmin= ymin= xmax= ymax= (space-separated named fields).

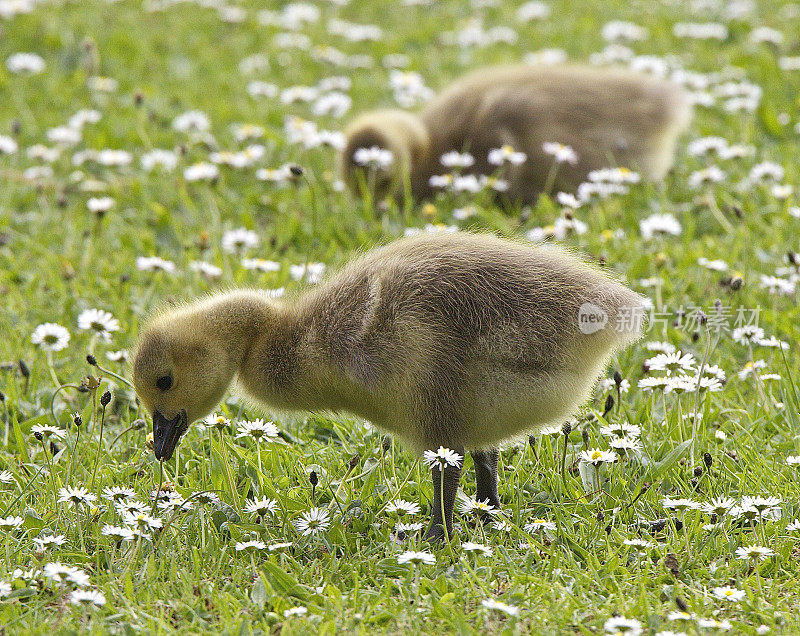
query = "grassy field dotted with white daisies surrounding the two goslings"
xmin=0 ymin=0 xmax=800 ymax=634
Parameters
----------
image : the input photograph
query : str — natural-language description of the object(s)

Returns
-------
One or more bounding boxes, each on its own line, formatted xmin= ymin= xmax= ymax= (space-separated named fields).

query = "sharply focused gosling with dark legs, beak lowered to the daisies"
xmin=133 ymin=233 xmax=642 ymax=538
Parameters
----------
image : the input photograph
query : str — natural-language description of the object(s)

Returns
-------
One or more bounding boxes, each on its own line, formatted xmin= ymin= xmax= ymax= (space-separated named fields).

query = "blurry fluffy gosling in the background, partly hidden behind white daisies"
xmin=339 ymin=66 xmax=691 ymax=203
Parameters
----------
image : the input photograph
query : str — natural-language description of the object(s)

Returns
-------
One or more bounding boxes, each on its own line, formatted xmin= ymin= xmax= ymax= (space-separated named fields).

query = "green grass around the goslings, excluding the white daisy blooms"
xmin=0 ymin=0 xmax=800 ymax=634
